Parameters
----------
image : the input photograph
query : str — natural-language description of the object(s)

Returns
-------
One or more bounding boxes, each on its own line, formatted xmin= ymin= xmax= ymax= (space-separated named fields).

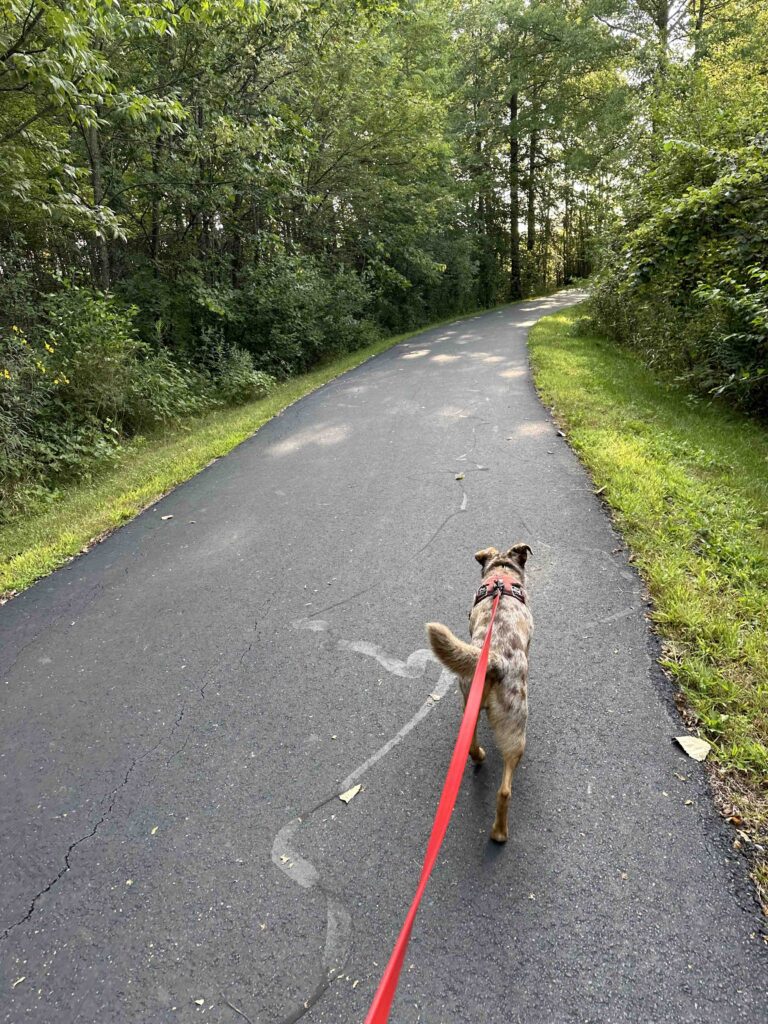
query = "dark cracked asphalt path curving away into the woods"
xmin=0 ymin=293 xmax=768 ymax=1024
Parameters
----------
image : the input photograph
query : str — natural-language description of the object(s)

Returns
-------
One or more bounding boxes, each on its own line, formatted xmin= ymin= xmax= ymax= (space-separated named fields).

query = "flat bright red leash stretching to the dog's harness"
xmin=366 ymin=592 xmax=502 ymax=1024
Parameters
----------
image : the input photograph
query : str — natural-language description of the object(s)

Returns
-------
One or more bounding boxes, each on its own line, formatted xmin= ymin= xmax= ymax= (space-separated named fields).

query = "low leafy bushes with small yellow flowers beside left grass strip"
xmin=0 ymin=287 xmax=272 ymax=518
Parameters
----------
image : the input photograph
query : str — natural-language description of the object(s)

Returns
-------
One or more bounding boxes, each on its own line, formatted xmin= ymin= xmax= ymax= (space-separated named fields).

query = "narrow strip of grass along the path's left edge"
xmin=0 ymin=310 xmax=512 ymax=603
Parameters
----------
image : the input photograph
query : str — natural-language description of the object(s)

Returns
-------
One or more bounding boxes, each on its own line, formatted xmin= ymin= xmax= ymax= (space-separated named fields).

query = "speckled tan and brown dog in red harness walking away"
xmin=427 ymin=544 xmax=534 ymax=843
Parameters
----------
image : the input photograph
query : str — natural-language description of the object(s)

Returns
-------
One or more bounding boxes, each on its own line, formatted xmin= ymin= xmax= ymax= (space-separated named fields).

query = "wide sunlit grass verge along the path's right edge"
xmin=530 ymin=307 xmax=768 ymax=906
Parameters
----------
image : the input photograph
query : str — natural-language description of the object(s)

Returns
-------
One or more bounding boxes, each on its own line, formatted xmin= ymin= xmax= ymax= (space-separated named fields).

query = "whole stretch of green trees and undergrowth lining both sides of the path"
xmin=0 ymin=0 xmax=768 ymax=512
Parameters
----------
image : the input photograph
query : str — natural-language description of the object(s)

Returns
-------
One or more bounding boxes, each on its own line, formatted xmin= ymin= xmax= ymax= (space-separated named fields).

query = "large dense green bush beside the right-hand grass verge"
xmin=591 ymin=139 xmax=768 ymax=416
